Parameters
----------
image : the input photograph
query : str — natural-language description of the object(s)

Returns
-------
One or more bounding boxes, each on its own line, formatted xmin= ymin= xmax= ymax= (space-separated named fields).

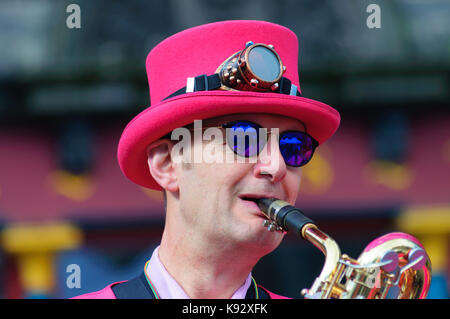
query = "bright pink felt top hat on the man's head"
xmin=118 ymin=20 xmax=340 ymax=190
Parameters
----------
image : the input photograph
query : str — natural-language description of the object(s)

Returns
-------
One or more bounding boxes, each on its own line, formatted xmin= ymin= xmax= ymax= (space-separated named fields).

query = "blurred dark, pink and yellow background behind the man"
xmin=0 ymin=0 xmax=450 ymax=298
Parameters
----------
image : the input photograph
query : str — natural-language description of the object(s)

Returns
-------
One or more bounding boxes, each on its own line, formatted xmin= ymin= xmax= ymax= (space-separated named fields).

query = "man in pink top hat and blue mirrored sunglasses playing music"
xmin=74 ymin=21 xmax=340 ymax=299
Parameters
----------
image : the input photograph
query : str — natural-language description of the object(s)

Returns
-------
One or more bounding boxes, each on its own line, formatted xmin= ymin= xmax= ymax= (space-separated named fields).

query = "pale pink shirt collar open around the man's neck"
xmin=145 ymin=246 xmax=252 ymax=299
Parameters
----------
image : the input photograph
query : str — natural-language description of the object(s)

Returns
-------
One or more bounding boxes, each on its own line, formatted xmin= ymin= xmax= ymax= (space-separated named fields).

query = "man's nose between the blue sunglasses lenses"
xmin=254 ymin=134 xmax=286 ymax=183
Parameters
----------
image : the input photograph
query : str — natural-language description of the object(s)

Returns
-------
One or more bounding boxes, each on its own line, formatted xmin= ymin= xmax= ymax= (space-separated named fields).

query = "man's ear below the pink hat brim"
xmin=147 ymin=139 xmax=178 ymax=192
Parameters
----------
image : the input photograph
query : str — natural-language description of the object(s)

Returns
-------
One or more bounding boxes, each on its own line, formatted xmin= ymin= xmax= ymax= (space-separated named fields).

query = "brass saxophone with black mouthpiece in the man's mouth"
xmin=255 ymin=198 xmax=431 ymax=299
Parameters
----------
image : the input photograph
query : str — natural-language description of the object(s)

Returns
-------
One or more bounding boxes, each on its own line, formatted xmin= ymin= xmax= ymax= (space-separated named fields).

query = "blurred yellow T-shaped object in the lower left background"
xmin=1 ymin=222 xmax=83 ymax=296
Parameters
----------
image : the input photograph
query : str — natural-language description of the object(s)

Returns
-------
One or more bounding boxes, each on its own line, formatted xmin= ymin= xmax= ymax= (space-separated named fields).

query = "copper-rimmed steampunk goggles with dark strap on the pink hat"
xmin=164 ymin=41 xmax=302 ymax=100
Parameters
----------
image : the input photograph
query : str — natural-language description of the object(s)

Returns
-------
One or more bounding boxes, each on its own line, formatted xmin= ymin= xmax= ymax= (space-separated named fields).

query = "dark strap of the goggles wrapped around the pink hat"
xmin=163 ymin=73 xmax=302 ymax=101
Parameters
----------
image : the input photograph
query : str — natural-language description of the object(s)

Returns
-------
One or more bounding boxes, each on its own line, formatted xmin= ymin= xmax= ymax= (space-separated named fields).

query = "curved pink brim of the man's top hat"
xmin=117 ymin=91 xmax=340 ymax=190
